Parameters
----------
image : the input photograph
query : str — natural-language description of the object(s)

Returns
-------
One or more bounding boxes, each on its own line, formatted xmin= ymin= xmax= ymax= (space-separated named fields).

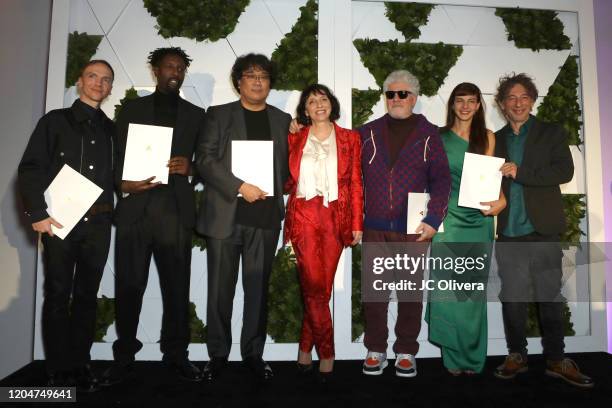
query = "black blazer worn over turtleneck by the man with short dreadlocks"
xmin=115 ymin=95 xmax=205 ymax=228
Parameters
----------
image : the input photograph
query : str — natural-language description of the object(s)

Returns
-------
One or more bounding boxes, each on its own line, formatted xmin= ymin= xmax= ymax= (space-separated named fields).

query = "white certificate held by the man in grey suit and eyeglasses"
xmin=232 ymin=140 xmax=274 ymax=196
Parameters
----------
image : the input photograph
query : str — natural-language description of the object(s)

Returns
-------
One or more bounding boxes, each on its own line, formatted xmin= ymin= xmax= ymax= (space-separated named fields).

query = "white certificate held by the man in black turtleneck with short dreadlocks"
xmin=121 ymin=123 xmax=173 ymax=184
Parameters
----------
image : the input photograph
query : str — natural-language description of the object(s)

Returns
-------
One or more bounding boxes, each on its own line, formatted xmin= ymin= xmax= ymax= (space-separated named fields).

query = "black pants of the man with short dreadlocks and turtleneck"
xmin=113 ymin=189 xmax=192 ymax=363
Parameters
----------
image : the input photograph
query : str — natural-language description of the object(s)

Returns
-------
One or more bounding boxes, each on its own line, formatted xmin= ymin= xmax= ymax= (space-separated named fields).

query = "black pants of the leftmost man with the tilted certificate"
xmin=42 ymin=214 xmax=111 ymax=372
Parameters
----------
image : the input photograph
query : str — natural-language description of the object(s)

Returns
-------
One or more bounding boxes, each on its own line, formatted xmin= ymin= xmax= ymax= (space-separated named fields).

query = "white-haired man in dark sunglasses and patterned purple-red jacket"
xmin=359 ymin=71 xmax=451 ymax=377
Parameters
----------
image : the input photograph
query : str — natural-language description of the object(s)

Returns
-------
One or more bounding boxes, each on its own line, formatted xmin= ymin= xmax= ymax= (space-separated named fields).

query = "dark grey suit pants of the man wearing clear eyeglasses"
xmin=206 ymin=225 xmax=280 ymax=359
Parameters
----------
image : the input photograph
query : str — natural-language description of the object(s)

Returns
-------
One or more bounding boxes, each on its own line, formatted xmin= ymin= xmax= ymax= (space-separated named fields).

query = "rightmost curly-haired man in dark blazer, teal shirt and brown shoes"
xmin=495 ymin=74 xmax=593 ymax=387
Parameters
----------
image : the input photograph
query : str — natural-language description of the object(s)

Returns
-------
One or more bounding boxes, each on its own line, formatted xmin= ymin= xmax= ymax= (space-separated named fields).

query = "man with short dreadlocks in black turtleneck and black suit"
xmin=102 ymin=47 xmax=205 ymax=385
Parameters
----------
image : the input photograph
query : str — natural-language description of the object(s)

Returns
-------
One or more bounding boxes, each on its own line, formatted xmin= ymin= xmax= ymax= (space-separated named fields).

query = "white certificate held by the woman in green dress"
xmin=458 ymin=153 xmax=504 ymax=210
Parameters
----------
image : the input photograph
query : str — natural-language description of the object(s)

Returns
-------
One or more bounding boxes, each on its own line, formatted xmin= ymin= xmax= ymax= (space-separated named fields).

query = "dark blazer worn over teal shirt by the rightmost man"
xmin=495 ymin=118 xmax=574 ymax=235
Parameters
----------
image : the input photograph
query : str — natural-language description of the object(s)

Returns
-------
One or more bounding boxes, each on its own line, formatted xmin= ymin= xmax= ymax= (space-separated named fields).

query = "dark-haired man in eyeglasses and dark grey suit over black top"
xmin=196 ymin=54 xmax=291 ymax=381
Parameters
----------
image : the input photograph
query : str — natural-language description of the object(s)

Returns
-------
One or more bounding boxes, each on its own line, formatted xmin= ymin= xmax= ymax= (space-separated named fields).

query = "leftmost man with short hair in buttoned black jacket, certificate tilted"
xmin=18 ymin=60 xmax=115 ymax=391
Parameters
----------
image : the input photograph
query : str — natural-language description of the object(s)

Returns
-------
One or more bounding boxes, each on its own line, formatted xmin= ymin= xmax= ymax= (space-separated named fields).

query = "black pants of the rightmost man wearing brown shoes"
xmin=495 ymin=232 xmax=565 ymax=360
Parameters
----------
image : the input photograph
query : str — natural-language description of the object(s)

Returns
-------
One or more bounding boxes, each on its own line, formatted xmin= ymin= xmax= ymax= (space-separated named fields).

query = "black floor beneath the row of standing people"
xmin=0 ymin=353 xmax=612 ymax=408
